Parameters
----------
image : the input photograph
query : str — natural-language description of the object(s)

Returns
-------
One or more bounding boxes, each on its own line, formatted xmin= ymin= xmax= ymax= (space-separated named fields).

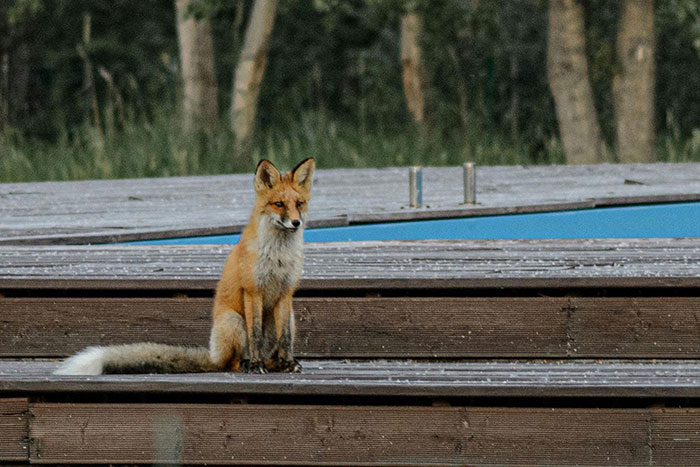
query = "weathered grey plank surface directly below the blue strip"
xmin=0 ymin=239 xmax=700 ymax=293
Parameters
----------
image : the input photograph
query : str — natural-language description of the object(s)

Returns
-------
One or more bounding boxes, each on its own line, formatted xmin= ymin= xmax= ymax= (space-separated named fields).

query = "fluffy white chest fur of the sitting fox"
xmin=253 ymin=217 xmax=304 ymax=310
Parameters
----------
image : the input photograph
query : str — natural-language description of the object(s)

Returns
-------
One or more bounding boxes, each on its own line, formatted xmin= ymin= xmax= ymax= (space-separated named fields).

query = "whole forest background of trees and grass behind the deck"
xmin=0 ymin=0 xmax=700 ymax=182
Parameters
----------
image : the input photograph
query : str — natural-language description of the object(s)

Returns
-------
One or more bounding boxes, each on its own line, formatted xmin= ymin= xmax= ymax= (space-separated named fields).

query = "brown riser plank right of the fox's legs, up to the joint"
xmin=295 ymin=297 xmax=568 ymax=358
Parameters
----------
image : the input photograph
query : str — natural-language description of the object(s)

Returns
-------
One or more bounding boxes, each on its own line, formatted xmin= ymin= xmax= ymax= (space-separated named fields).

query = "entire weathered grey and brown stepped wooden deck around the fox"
xmin=0 ymin=165 xmax=700 ymax=466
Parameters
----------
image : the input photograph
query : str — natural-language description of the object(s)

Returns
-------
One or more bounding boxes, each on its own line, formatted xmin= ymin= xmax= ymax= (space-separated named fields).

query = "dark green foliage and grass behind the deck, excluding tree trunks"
xmin=0 ymin=0 xmax=700 ymax=181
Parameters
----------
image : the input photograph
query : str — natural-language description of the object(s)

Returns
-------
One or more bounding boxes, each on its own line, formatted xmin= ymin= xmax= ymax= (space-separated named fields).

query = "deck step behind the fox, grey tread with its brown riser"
xmin=0 ymin=239 xmax=700 ymax=359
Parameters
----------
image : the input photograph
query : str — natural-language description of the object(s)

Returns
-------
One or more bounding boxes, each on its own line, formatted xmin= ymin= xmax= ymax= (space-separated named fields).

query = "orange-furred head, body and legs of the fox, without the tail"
xmin=210 ymin=159 xmax=315 ymax=372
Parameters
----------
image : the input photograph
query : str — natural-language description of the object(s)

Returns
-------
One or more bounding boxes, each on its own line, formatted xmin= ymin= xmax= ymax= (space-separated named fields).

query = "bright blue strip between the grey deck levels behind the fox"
xmin=133 ymin=202 xmax=700 ymax=245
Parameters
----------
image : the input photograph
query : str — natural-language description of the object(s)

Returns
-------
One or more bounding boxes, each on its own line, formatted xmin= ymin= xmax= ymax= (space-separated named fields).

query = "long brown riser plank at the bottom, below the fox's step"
xmin=30 ymin=403 xmax=652 ymax=465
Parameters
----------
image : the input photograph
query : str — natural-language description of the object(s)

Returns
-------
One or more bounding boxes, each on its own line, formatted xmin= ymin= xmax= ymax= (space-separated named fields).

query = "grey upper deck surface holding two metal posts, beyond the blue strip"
xmin=0 ymin=164 xmax=700 ymax=244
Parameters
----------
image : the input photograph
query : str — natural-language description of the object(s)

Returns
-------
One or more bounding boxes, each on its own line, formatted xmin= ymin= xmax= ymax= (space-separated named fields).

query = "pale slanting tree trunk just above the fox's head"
xmin=231 ymin=0 xmax=277 ymax=157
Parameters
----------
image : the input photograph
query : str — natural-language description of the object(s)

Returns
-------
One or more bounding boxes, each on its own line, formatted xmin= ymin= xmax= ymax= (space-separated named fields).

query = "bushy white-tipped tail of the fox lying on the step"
xmin=54 ymin=342 xmax=221 ymax=375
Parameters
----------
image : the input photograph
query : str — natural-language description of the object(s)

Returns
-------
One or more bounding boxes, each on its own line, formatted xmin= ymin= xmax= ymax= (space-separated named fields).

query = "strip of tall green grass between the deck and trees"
xmin=0 ymin=109 xmax=700 ymax=182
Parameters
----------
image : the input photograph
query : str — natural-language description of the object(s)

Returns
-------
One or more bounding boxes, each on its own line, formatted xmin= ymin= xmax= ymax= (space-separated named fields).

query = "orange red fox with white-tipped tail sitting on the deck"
xmin=54 ymin=158 xmax=316 ymax=375
